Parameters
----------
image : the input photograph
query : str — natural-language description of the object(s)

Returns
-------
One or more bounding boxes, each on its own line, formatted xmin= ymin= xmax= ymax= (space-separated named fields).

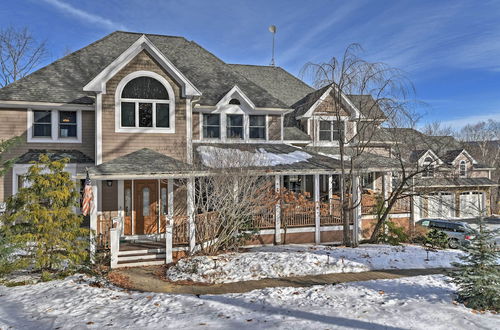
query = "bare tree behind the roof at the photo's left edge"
xmin=0 ymin=27 xmax=47 ymax=87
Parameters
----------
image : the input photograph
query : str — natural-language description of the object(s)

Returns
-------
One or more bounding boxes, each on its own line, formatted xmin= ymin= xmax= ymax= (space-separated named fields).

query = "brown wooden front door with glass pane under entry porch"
xmin=134 ymin=180 xmax=158 ymax=235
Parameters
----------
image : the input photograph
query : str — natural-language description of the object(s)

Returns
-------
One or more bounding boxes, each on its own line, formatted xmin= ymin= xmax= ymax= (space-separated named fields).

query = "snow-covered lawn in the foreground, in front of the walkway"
xmin=0 ymin=275 xmax=500 ymax=330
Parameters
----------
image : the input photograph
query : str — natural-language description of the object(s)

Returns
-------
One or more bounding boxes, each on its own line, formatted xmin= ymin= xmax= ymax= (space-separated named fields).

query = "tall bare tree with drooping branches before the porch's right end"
xmin=302 ymin=44 xmax=414 ymax=245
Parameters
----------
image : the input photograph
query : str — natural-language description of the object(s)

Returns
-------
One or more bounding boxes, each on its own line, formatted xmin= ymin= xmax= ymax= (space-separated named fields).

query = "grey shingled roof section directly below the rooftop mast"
xmin=229 ymin=64 xmax=314 ymax=106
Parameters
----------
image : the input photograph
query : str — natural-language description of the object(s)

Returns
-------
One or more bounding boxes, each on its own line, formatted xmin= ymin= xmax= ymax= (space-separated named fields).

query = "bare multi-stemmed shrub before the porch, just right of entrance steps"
xmin=195 ymin=146 xmax=276 ymax=255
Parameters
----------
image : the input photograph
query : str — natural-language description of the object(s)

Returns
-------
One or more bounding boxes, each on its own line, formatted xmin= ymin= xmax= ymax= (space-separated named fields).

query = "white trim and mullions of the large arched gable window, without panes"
xmin=115 ymin=71 xmax=175 ymax=133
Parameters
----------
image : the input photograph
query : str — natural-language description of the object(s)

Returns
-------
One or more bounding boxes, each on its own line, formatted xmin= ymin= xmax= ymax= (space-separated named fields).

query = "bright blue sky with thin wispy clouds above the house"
xmin=0 ymin=0 xmax=500 ymax=127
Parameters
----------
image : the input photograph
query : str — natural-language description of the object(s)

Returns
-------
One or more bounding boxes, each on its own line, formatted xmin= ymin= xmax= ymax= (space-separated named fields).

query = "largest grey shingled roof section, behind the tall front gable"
xmin=0 ymin=31 xmax=288 ymax=108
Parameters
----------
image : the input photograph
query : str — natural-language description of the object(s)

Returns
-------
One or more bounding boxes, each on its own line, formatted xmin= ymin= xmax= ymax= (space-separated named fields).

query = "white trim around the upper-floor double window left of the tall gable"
xmin=27 ymin=109 xmax=82 ymax=143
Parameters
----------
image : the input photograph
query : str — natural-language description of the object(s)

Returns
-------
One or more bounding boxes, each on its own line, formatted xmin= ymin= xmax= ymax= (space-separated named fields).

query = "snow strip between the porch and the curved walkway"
xmin=167 ymin=244 xmax=462 ymax=283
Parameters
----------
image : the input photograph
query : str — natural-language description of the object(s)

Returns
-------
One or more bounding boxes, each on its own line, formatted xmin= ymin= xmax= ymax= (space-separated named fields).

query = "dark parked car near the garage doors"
xmin=416 ymin=219 xmax=474 ymax=249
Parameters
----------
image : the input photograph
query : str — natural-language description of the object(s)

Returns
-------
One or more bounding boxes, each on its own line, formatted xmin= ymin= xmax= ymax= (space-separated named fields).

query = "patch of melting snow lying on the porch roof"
xmin=197 ymin=146 xmax=312 ymax=168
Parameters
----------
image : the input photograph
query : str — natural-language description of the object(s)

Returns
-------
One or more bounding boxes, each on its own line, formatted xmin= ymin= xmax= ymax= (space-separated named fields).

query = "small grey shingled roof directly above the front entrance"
xmin=89 ymin=148 xmax=194 ymax=176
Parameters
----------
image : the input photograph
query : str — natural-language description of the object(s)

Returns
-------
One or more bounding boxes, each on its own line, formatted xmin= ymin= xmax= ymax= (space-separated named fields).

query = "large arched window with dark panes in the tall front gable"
xmin=117 ymin=71 xmax=175 ymax=132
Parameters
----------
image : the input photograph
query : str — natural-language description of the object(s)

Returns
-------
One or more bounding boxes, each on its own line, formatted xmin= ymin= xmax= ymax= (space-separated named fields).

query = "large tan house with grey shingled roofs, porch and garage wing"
xmin=0 ymin=32 xmax=492 ymax=267
